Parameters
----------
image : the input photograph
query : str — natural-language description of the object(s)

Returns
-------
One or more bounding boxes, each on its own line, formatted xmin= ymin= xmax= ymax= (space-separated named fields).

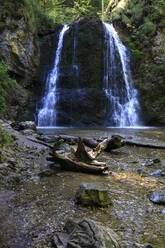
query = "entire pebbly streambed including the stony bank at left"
xmin=0 ymin=122 xmax=165 ymax=248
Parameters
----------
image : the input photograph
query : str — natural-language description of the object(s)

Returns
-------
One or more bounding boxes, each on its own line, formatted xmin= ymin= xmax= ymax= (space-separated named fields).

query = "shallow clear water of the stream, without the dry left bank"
xmin=0 ymin=129 xmax=165 ymax=248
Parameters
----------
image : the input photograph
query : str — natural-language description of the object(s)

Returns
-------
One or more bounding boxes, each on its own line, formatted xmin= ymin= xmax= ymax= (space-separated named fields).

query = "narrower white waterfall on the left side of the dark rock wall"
xmin=38 ymin=25 xmax=69 ymax=127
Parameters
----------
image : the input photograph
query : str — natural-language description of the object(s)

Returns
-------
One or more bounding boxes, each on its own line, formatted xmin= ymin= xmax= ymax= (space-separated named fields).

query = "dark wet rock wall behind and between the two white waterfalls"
xmin=39 ymin=17 xmax=105 ymax=126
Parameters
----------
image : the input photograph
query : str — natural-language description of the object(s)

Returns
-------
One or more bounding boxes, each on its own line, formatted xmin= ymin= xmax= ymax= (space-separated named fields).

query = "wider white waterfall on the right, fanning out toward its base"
xmin=103 ymin=23 xmax=139 ymax=127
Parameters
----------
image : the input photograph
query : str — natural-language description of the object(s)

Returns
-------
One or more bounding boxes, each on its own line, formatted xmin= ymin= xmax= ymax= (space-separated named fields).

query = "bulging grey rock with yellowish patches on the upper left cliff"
xmin=0 ymin=16 xmax=39 ymax=81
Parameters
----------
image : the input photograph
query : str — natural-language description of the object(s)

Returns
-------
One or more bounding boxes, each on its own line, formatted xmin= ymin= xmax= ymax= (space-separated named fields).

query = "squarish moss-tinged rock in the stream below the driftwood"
xmin=76 ymin=183 xmax=111 ymax=207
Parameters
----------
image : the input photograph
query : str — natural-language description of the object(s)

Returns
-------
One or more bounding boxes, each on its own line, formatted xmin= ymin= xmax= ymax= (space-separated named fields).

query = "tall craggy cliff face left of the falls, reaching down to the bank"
xmin=0 ymin=1 xmax=39 ymax=119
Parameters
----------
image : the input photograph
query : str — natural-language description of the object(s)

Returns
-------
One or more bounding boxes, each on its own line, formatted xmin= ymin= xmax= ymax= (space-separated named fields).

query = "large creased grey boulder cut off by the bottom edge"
xmin=53 ymin=219 xmax=120 ymax=248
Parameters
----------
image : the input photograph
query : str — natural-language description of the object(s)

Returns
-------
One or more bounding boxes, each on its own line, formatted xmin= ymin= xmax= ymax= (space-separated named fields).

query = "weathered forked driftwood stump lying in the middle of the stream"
xmin=49 ymin=136 xmax=123 ymax=174
